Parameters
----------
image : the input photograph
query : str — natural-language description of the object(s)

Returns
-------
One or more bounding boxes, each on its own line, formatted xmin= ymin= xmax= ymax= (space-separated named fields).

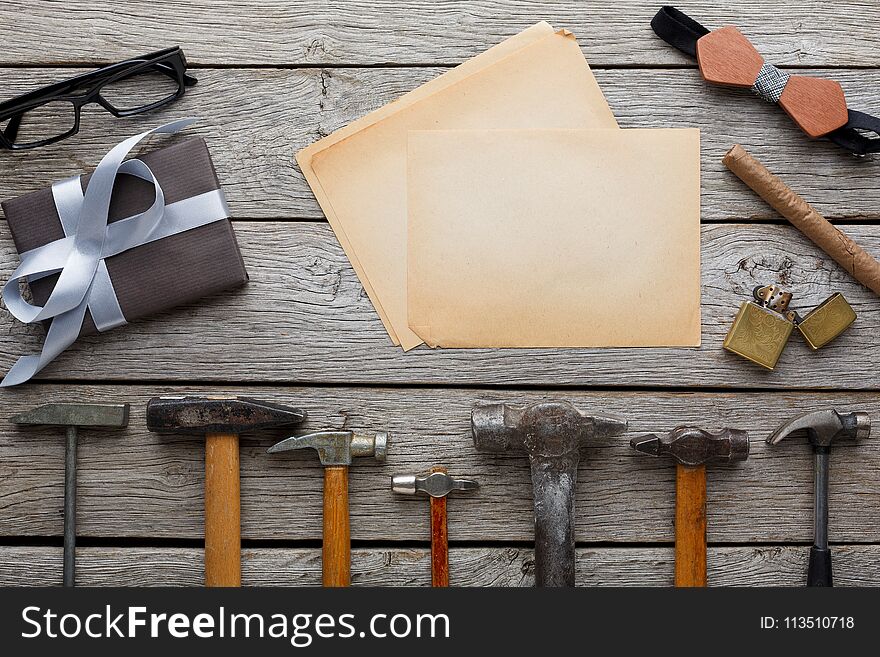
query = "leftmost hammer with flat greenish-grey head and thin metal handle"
xmin=10 ymin=404 xmax=128 ymax=586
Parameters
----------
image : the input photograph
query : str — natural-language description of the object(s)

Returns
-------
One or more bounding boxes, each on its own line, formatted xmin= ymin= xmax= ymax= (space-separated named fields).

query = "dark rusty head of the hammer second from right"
xmin=630 ymin=427 xmax=749 ymax=466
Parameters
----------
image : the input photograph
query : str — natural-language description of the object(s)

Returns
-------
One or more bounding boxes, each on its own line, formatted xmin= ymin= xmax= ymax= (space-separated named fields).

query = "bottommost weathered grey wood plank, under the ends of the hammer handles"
xmin=0 ymin=545 xmax=880 ymax=586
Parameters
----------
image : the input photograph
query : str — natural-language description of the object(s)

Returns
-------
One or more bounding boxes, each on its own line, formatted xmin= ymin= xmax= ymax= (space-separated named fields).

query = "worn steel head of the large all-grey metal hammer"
xmin=471 ymin=401 xmax=627 ymax=458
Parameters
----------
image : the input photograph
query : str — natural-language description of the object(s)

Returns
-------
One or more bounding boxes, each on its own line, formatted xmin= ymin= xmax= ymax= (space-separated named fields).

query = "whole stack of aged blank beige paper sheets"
xmin=297 ymin=23 xmax=700 ymax=350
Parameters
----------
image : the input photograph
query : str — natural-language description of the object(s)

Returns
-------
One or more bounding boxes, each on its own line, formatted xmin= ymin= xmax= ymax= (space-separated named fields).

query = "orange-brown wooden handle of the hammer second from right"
xmin=675 ymin=464 xmax=706 ymax=586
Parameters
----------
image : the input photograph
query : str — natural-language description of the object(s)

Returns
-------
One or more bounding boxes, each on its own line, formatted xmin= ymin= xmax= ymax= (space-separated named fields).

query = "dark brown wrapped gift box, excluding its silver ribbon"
xmin=0 ymin=138 xmax=248 ymax=335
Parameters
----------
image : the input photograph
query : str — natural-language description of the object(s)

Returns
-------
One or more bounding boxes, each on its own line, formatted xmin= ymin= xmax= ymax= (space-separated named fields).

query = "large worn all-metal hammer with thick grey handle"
xmin=471 ymin=401 xmax=626 ymax=586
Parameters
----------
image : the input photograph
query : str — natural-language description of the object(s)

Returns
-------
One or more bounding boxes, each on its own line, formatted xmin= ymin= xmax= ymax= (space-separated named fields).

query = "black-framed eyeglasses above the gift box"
xmin=0 ymin=47 xmax=198 ymax=150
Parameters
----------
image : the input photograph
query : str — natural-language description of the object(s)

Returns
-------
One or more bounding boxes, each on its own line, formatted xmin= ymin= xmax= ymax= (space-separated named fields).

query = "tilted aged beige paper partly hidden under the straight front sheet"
xmin=297 ymin=24 xmax=617 ymax=349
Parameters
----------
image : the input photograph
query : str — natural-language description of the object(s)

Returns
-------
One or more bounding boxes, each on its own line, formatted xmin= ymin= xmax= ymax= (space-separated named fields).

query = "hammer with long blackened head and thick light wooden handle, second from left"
xmin=147 ymin=395 xmax=306 ymax=586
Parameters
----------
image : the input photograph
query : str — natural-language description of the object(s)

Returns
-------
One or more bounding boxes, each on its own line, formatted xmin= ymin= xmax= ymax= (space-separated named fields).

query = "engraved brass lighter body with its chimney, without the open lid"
xmin=724 ymin=285 xmax=806 ymax=370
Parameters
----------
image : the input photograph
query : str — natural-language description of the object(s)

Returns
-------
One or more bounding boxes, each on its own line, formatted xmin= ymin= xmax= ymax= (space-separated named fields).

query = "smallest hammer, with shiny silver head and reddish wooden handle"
xmin=391 ymin=467 xmax=480 ymax=586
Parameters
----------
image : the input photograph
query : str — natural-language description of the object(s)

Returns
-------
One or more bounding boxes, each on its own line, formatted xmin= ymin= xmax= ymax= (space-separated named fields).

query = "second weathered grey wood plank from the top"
xmin=0 ymin=68 xmax=880 ymax=221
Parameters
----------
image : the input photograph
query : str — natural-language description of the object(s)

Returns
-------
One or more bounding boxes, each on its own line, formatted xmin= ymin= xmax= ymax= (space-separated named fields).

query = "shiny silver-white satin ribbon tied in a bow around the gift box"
xmin=0 ymin=119 xmax=229 ymax=386
